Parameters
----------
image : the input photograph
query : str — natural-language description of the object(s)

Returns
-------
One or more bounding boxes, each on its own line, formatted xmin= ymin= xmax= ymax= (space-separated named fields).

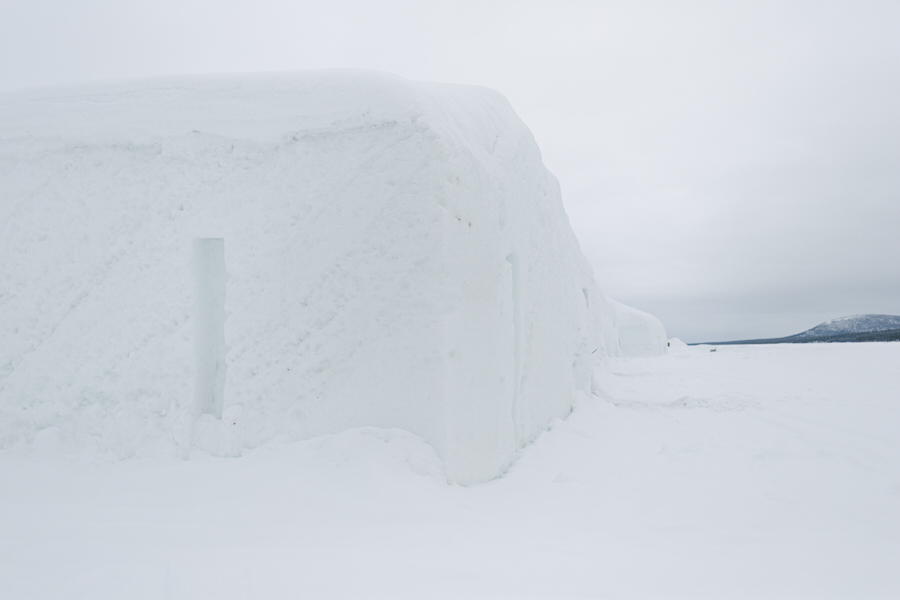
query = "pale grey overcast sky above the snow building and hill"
xmin=0 ymin=0 xmax=900 ymax=341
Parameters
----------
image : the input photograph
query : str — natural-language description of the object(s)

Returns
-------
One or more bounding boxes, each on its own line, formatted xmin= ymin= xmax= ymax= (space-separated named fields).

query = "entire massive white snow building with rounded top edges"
xmin=0 ymin=71 xmax=665 ymax=484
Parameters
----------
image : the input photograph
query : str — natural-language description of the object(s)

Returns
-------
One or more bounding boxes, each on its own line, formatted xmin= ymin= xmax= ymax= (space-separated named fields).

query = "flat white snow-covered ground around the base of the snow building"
xmin=0 ymin=343 xmax=900 ymax=599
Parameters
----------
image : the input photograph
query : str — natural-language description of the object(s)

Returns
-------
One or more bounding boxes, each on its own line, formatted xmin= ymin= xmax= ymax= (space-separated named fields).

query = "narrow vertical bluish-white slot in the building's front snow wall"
xmin=191 ymin=238 xmax=226 ymax=418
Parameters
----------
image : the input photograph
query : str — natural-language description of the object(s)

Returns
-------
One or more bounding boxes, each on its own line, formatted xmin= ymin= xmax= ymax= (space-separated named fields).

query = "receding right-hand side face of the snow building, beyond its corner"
xmin=424 ymin=88 xmax=605 ymax=483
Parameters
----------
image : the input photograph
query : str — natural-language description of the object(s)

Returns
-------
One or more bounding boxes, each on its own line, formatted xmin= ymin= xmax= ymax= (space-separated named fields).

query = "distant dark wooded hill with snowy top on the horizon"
xmin=691 ymin=315 xmax=900 ymax=346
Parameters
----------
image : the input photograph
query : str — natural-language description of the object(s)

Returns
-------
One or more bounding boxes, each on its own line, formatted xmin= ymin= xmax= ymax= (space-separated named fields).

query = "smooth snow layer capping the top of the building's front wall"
xmin=0 ymin=69 xmax=530 ymax=146
